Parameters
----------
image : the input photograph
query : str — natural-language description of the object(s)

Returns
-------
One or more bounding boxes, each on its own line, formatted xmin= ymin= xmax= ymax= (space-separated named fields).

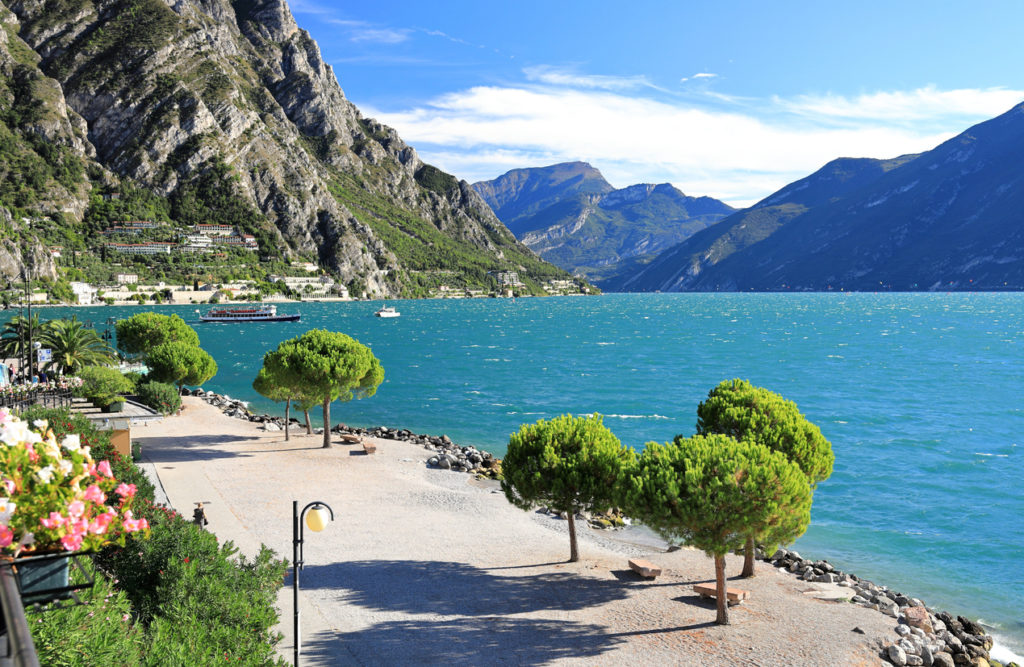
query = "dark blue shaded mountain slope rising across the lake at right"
xmin=602 ymin=105 xmax=1024 ymax=291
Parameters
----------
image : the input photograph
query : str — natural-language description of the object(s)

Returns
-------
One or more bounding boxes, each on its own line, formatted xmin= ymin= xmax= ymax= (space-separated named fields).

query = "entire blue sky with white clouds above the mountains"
xmin=290 ymin=0 xmax=1024 ymax=206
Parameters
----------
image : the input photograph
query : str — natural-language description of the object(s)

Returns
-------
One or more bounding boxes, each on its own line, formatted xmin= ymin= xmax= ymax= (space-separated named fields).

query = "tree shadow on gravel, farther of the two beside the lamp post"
xmin=302 ymin=560 xmax=643 ymax=616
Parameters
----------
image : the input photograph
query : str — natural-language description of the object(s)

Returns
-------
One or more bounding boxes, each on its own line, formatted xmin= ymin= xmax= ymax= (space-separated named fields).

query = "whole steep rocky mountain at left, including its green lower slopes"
xmin=0 ymin=0 xmax=566 ymax=296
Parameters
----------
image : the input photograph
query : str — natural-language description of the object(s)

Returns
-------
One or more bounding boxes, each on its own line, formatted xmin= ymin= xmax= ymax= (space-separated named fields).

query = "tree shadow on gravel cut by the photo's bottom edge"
xmin=302 ymin=617 xmax=626 ymax=665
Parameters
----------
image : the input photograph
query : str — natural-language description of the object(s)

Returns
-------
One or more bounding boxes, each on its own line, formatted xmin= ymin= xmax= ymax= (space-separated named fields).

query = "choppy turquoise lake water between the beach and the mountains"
xmin=19 ymin=293 xmax=1024 ymax=655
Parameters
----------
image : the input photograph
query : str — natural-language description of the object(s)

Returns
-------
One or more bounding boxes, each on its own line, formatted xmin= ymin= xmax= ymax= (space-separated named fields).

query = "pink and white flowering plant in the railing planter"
xmin=0 ymin=408 xmax=150 ymax=555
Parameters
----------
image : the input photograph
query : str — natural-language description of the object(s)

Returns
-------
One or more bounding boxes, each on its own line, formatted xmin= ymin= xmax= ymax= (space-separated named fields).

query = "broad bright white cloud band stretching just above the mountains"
xmin=364 ymin=76 xmax=1024 ymax=206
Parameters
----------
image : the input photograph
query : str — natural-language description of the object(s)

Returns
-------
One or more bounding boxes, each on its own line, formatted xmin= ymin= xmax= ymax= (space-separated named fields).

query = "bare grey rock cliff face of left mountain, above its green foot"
xmin=0 ymin=0 xmax=559 ymax=295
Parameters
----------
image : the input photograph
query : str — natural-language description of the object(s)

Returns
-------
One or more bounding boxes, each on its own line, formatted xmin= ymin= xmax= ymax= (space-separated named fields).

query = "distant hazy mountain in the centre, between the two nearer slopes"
xmin=473 ymin=162 xmax=733 ymax=280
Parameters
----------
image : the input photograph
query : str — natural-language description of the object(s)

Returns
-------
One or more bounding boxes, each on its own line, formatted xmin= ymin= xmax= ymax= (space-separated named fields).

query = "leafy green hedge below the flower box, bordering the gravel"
xmin=23 ymin=408 xmax=287 ymax=667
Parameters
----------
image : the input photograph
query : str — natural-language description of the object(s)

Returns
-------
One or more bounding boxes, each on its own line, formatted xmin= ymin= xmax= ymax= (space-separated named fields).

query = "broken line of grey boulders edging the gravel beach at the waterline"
xmin=190 ymin=389 xmax=1020 ymax=667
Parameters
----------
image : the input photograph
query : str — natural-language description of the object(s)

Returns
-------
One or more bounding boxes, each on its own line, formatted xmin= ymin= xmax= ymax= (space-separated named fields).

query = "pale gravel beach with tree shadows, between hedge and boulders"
xmin=133 ymin=397 xmax=895 ymax=666
